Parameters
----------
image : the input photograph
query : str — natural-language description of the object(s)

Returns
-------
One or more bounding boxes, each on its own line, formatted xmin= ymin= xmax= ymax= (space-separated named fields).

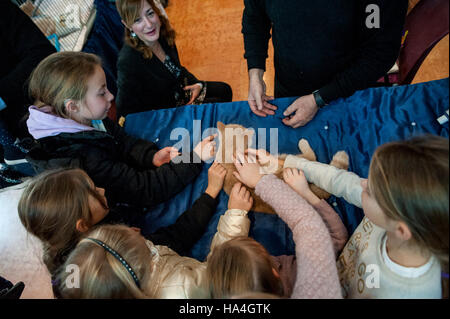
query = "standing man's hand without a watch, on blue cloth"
xmin=248 ymin=69 xmax=277 ymax=117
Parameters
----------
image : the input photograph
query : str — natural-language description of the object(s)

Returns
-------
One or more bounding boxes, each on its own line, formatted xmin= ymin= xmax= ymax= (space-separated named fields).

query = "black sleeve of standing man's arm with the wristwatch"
xmin=319 ymin=0 xmax=408 ymax=103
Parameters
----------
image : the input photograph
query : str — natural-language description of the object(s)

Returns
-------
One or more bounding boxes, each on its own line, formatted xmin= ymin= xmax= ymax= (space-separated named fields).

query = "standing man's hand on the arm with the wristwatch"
xmin=283 ymin=94 xmax=319 ymax=128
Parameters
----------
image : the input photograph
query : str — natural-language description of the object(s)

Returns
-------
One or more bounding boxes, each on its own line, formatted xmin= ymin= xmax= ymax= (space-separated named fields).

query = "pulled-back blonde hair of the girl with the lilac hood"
xmin=28 ymin=52 xmax=102 ymax=118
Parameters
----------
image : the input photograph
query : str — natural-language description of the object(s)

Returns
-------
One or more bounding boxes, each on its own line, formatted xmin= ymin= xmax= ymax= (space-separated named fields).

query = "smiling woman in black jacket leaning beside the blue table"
xmin=116 ymin=0 xmax=232 ymax=116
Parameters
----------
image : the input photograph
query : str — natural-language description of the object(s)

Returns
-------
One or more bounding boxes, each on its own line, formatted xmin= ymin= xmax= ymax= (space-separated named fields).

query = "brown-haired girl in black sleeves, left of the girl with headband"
xmin=18 ymin=163 xmax=225 ymax=297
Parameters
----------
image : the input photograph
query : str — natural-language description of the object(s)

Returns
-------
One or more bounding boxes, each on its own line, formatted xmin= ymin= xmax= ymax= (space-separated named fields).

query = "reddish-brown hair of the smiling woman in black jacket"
xmin=116 ymin=0 xmax=175 ymax=59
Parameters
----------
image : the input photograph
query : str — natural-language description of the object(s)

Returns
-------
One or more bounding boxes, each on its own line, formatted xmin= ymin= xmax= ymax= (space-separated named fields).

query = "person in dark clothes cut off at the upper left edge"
xmin=0 ymin=0 xmax=56 ymax=187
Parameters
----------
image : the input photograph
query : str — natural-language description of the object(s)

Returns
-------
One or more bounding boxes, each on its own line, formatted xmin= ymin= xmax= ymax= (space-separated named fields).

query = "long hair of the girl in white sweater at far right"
xmin=369 ymin=135 xmax=449 ymax=298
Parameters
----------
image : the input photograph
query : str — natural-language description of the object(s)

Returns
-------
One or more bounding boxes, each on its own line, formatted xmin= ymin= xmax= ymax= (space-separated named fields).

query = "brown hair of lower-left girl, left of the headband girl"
xmin=18 ymin=168 xmax=106 ymax=274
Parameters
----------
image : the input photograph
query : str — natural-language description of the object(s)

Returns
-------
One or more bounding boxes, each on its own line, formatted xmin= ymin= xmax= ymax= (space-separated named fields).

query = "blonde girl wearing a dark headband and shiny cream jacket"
xmin=54 ymin=183 xmax=253 ymax=299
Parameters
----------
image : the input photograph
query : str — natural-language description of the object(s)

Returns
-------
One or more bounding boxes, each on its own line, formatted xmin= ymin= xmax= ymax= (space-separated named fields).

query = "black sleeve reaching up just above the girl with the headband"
xmin=147 ymin=193 xmax=218 ymax=256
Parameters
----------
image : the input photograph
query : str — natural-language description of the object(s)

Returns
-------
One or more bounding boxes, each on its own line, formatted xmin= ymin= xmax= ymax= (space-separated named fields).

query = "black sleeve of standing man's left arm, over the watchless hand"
xmin=242 ymin=0 xmax=272 ymax=70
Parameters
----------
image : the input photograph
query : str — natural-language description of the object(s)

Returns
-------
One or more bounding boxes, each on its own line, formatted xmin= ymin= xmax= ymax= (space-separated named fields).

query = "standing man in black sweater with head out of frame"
xmin=242 ymin=0 xmax=408 ymax=128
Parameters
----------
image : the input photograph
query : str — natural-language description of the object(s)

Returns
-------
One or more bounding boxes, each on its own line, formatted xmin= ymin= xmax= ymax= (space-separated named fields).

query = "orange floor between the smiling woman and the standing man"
xmin=166 ymin=0 xmax=274 ymax=101
